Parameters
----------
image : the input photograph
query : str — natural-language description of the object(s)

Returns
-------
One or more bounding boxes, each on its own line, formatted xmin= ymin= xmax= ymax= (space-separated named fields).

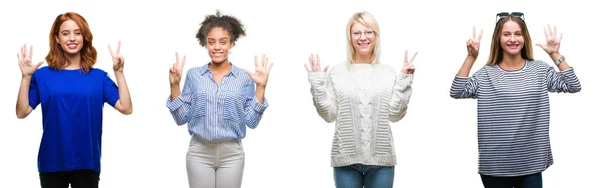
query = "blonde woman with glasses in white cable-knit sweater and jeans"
xmin=305 ymin=12 xmax=417 ymax=188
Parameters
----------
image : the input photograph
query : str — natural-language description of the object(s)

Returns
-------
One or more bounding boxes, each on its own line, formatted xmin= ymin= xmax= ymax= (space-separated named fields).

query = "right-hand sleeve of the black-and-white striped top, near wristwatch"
xmin=546 ymin=66 xmax=581 ymax=93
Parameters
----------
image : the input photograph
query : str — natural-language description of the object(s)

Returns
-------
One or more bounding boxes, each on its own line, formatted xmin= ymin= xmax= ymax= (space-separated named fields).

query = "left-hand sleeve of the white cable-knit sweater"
xmin=308 ymin=72 xmax=338 ymax=123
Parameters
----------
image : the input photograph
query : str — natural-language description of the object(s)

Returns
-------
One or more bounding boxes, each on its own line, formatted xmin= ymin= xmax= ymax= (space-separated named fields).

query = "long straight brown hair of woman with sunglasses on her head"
xmin=486 ymin=15 xmax=533 ymax=65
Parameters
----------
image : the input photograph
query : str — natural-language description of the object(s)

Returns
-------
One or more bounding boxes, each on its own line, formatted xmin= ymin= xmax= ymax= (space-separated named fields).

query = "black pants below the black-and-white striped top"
xmin=481 ymin=173 xmax=542 ymax=188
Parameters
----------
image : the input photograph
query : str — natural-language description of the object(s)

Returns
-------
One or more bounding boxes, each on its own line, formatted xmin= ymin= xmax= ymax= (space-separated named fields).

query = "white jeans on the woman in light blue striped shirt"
xmin=186 ymin=136 xmax=244 ymax=188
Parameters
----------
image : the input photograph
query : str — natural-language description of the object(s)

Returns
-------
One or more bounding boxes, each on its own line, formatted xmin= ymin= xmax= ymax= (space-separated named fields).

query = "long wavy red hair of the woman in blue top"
xmin=46 ymin=12 xmax=97 ymax=73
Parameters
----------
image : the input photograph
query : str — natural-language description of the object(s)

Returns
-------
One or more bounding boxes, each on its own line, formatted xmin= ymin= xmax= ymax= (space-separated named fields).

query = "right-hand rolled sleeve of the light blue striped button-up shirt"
xmin=244 ymin=80 xmax=269 ymax=129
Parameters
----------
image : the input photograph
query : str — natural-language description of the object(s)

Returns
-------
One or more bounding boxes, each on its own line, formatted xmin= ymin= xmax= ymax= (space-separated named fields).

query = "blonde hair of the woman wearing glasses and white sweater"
xmin=346 ymin=11 xmax=380 ymax=64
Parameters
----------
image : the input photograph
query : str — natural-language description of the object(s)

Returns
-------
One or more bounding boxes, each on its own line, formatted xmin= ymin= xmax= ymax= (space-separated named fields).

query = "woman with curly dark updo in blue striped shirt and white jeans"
xmin=166 ymin=11 xmax=272 ymax=188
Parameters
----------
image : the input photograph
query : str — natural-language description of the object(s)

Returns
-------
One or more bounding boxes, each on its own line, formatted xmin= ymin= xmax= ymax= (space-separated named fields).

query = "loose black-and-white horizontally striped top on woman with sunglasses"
xmin=450 ymin=61 xmax=581 ymax=176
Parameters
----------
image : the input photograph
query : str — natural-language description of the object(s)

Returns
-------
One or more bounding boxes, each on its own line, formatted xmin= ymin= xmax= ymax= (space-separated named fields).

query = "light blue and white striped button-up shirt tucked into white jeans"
xmin=167 ymin=64 xmax=268 ymax=141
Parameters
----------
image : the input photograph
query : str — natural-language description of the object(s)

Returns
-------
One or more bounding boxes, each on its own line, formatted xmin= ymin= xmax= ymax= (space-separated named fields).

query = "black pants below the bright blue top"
xmin=40 ymin=170 xmax=100 ymax=188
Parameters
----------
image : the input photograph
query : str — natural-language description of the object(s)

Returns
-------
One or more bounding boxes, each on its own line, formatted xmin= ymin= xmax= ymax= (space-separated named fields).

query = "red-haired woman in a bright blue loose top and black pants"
xmin=16 ymin=12 xmax=133 ymax=188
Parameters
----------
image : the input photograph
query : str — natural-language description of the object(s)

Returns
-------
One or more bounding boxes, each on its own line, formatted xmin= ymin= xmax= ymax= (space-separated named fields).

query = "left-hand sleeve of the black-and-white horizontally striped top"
xmin=450 ymin=69 xmax=483 ymax=99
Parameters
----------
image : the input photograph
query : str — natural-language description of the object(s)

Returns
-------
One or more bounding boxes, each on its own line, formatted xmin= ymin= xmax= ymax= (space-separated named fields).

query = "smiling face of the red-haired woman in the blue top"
xmin=56 ymin=20 xmax=83 ymax=55
